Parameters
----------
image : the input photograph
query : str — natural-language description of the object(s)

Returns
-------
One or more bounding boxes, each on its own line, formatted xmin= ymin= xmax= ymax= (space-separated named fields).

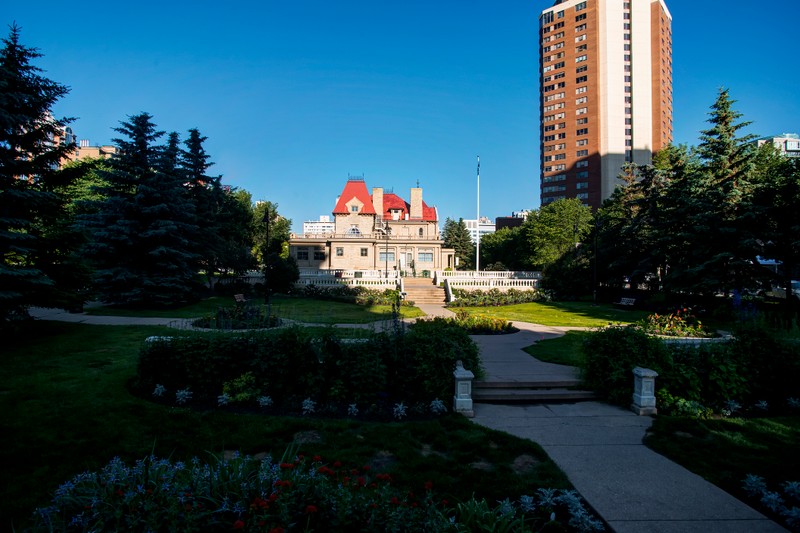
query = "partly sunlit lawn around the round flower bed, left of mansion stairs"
xmin=87 ymin=296 xmax=424 ymax=324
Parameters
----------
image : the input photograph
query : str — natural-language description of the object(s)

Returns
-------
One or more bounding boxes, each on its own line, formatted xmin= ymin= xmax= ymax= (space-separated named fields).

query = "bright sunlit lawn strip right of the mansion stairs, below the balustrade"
xmin=459 ymin=302 xmax=647 ymax=328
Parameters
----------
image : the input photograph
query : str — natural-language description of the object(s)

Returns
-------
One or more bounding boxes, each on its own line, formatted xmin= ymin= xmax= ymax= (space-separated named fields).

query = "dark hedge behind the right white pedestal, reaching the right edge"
xmin=583 ymin=326 xmax=800 ymax=414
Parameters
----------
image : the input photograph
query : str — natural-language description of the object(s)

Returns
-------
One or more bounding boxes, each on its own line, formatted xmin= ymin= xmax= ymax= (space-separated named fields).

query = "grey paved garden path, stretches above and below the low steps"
xmin=30 ymin=305 xmax=785 ymax=533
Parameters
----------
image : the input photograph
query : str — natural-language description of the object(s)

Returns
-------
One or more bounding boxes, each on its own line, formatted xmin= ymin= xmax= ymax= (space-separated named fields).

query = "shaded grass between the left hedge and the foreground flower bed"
xmin=0 ymin=322 xmax=569 ymax=529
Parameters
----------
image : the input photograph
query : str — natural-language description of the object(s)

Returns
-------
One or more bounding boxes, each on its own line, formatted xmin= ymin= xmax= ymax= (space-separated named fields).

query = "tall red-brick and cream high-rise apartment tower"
xmin=539 ymin=0 xmax=672 ymax=209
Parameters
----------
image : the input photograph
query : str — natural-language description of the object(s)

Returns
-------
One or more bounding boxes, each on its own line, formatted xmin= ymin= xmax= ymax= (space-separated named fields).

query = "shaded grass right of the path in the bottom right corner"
xmin=645 ymin=416 xmax=800 ymax=519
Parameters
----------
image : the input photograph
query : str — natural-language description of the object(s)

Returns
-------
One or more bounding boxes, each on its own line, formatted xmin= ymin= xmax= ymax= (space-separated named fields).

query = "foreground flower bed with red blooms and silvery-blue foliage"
xmin=33 ymin=454 xmax=603 ymax=533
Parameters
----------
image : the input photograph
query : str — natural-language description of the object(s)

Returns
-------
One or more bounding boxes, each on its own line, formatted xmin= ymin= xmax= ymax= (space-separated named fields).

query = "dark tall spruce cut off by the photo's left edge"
xmin=0 ymin=25 xmax=74 ymax=323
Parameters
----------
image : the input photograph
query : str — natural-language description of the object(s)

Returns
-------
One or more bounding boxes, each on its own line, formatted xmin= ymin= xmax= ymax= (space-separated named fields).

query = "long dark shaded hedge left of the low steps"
xmin=135 ymin=321 xmax=483 ymax=410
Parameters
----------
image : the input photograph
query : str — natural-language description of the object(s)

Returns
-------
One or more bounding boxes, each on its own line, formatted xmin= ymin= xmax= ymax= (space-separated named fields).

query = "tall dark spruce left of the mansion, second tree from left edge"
xmin=85 ymin=113 xmax=195 ymax=305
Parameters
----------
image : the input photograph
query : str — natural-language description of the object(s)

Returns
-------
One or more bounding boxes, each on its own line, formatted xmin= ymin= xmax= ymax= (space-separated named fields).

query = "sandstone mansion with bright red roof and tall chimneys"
xmin=289 ymin=178 xmax=455 ymax=275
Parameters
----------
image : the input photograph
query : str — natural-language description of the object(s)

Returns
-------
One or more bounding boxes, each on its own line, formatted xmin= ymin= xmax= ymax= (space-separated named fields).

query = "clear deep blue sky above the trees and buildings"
xmin=6 ymin=0 xmax=800 ymax=231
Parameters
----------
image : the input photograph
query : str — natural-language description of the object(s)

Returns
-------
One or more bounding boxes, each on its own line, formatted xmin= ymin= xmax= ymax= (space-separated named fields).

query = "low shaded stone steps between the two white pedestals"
xmin=472 ymin=379 xmax=597 ymax=403
